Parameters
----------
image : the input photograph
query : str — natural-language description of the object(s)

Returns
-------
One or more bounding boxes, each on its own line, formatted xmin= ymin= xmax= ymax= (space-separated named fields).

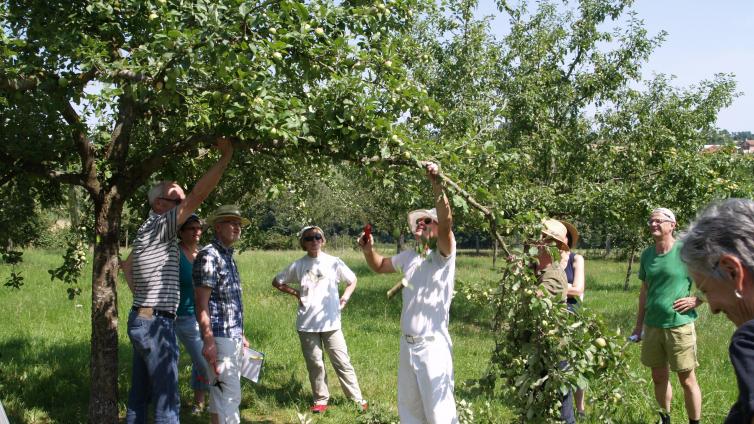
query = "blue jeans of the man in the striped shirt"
xmin=126 ymin=311 xmax=180 ymax=424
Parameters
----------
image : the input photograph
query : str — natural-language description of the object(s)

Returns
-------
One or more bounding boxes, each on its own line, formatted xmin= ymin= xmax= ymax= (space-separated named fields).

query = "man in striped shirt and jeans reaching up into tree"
xmin=123 ymin=138 xmax=233 ymax=424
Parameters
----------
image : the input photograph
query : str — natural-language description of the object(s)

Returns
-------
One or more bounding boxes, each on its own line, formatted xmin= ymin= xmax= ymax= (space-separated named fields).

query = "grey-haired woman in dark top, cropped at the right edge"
xmin=681 ymin=199 xmax=754 ymax=424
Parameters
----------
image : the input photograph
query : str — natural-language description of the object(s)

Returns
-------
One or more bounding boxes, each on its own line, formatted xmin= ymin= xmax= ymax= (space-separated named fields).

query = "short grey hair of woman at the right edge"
xmin=680 ymin=199 xmax=754 ymax=278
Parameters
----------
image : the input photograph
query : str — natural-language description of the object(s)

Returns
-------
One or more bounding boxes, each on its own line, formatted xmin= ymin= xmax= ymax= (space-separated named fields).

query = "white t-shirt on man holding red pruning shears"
xmin=391 ymin=250 xmax=456 ymax=343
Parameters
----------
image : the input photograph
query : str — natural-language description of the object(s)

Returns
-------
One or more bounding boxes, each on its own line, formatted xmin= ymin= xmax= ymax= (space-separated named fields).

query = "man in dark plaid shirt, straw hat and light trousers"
xmin=193 ymin=205 xmax=249 ymax=423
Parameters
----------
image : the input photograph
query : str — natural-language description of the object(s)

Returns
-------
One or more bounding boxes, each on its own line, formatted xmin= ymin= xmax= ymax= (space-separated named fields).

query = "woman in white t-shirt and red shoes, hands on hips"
xmin=272 ymin=226 xmax=367 ymax=413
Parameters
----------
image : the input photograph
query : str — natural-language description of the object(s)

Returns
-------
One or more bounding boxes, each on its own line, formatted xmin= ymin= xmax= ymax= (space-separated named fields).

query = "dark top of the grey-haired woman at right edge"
xmin=725 ymin=320 xmax=754 ymax=424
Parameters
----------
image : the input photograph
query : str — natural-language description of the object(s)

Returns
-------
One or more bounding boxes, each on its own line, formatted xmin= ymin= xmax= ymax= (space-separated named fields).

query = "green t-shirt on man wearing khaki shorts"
xmin=639 ymin=241 xmax=696 ymax=328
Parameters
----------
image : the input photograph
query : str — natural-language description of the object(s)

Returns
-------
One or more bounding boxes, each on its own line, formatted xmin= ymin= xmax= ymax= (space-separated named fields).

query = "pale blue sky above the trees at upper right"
xmin=478 ymin=0 xmax=754 ymax=132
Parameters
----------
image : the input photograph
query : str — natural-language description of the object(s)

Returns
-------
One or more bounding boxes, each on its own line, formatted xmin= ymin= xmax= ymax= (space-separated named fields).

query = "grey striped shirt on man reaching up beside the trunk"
xmin=132 ymin=207 xmax=180 ymax=313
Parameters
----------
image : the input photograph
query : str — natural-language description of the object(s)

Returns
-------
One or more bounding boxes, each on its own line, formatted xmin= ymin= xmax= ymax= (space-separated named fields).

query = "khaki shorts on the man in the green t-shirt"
xmin=641 ymin=322 xmax=699 ymax=372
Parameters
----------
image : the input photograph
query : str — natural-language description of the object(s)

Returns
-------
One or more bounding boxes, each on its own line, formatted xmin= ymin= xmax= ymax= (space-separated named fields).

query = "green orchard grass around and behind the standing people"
xmin=0 ymin=246 xmax=737 ymax=423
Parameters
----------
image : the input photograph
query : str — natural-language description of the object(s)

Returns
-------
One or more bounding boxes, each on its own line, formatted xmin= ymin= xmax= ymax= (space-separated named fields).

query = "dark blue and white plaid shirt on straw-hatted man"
xmin=193 ymin=239 xmax=243 ymax=338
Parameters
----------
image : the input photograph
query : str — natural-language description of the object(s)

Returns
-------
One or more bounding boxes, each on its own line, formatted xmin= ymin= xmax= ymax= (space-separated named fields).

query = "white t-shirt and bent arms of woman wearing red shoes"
xmin=275 ymin=252 xmax=356 ymax=333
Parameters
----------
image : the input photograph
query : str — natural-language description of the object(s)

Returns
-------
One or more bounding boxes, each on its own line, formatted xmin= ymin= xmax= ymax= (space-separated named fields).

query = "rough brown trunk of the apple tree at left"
xmin=89 ymin=190 xmax=123 ymax=423
